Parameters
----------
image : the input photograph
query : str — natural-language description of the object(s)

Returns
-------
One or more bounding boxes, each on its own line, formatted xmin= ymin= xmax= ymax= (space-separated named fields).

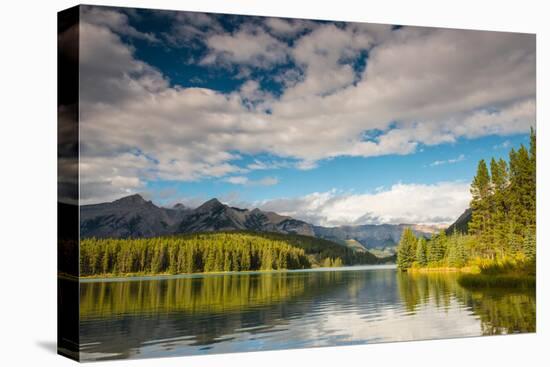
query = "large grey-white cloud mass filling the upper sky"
xmin=80 ymin=10 xmax=536 ymax=206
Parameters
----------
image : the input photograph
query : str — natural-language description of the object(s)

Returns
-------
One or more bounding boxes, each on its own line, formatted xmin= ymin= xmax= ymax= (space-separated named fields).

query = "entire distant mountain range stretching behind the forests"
xmin=80 ymin=194 xmax=460 ymax=252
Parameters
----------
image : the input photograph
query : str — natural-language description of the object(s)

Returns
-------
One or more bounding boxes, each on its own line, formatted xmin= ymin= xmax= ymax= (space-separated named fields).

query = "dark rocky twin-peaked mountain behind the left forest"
xmin=80 ymin=195 xmax=313 ymax=238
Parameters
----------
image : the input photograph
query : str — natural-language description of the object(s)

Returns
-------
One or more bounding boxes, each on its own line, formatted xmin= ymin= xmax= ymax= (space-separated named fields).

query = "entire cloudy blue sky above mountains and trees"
xmin=74 ymin=7 xmax=535 ymax=225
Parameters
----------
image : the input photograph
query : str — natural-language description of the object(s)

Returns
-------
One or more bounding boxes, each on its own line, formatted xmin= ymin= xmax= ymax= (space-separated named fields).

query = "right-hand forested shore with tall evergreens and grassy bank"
xmin=397 ymin=129 xmax=536 ymax=287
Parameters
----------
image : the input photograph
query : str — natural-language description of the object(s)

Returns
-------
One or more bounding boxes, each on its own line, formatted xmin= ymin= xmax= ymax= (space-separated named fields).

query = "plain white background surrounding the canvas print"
xmin=0 ymin=0 xmax=550 ymax=367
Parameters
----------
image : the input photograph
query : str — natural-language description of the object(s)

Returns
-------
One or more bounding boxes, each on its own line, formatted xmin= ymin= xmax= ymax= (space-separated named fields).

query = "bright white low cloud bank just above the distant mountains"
xmin=254 ymin=182 xmax=471 ymax=226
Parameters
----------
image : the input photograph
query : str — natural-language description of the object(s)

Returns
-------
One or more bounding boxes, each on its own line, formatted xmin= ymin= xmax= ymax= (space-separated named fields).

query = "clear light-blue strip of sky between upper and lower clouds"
xmin=147 ymin=134 xmax=528 ymax=205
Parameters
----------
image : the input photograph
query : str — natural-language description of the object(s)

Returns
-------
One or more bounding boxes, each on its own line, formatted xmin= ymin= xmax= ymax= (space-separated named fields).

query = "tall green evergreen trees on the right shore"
xmin=412 ymin=129 xmax=536 ymax=274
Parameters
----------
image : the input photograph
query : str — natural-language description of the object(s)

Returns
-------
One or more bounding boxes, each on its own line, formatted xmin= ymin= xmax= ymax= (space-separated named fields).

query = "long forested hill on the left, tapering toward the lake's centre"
xmin=80 ymin=231 xmax=392 ymax=276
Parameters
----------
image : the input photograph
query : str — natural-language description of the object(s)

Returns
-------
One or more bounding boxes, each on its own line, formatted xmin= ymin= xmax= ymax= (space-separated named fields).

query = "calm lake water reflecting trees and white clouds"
xmin=75 ymin=266 xmax=535 ymax=360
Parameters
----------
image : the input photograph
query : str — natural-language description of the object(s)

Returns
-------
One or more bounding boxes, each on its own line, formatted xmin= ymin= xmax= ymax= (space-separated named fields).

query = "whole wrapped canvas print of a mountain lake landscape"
xmin=58 ymin=5 xmax=537 ymax=361
